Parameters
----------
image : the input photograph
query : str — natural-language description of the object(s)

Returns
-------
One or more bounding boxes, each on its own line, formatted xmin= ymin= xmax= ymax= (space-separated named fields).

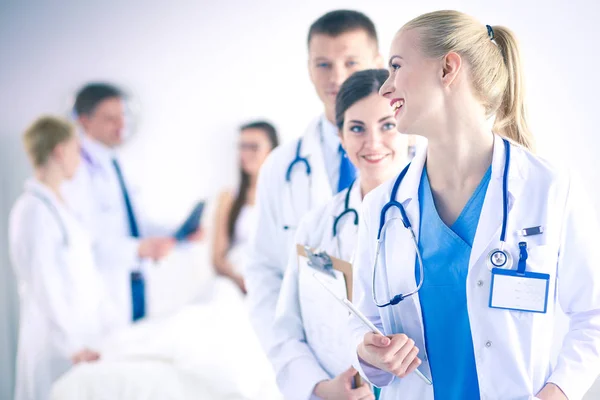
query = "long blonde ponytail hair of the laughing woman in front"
xmin=402 ymin=11 xmax=534 ymax=150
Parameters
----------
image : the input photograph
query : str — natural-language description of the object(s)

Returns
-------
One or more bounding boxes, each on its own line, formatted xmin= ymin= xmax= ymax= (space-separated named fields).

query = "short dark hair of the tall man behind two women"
xmin=307 ymin=10 xmax=378 ymax=46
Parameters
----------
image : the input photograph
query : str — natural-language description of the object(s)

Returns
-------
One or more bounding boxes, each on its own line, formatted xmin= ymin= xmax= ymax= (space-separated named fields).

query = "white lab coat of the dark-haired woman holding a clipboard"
xmin=269 ymin=181 xmax=362 ymax=400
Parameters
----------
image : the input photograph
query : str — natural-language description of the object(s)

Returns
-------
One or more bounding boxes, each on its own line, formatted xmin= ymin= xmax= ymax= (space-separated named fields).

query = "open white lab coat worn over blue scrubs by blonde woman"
xmin=350 ymin=136 xmax=600 ymax=400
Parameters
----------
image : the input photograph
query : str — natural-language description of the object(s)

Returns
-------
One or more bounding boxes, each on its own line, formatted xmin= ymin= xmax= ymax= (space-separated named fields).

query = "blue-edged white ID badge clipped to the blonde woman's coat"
xmin=489 ymin=268 xmax=550 ymax=314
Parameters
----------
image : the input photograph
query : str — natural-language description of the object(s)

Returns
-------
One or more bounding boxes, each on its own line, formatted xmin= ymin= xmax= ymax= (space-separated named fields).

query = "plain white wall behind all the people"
xmin=0 ymin=0 xmax=600 ymax=399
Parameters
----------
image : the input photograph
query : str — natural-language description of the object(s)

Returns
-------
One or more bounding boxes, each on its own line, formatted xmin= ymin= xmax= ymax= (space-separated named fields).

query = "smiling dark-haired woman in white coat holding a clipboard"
xmin=271 ymin=69 xmax=408 ymax=400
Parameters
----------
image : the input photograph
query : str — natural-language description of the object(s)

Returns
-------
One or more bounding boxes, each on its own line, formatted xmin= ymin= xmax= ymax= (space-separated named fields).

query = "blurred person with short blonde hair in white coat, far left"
xmin=9 ymin=117 xmax=116 ymax=400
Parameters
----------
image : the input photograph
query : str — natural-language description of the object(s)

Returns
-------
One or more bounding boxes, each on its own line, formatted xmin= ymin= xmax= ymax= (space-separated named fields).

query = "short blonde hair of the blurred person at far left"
xmin=23 ymin=116 xmax=75 ymax=168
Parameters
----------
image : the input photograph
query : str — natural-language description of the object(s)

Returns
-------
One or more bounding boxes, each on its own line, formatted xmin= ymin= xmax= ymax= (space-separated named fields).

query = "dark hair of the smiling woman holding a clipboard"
xmin=335 ymin=69 xmax=389 ymax=130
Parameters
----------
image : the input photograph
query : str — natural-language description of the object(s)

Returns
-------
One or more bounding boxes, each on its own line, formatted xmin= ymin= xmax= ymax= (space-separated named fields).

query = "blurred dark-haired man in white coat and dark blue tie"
xmin=62 ymin=83 xmax=196 ymax=326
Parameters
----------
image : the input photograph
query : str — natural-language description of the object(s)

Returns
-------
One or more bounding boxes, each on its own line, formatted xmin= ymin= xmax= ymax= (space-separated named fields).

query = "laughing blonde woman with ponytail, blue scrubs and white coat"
xmin=350 ymin=11 xmax=600 ymax=400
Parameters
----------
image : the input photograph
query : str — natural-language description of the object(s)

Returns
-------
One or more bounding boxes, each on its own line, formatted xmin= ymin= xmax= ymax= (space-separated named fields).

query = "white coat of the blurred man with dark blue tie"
xmin=62 ymin=135 xmax=167 ymax=326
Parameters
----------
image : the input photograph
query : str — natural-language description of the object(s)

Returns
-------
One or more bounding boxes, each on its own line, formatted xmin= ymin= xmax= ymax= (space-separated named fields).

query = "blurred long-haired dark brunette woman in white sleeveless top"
xmin=212 ymin=121 xmax=279 ymax=294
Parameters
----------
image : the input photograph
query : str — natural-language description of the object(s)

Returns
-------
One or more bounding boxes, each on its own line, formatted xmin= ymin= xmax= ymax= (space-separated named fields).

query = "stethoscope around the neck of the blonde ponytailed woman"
xmin=372 ymin=139 xmax=512 ymax=308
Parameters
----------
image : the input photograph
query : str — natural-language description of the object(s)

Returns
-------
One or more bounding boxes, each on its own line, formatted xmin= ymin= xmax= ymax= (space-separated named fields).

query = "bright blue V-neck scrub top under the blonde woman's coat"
xmin=415 ymin=167 xmax=491 ymax=400
